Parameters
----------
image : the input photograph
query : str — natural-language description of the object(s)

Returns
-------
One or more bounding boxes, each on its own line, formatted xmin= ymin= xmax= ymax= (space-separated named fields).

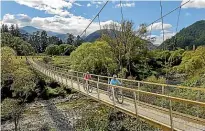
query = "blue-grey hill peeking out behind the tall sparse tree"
xmin=84 ymin=29 xmax=157 ymax=50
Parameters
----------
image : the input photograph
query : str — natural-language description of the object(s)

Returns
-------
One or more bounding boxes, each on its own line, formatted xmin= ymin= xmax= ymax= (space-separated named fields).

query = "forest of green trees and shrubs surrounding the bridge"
xmin=1 ymin=21 xmax=205 ymax=131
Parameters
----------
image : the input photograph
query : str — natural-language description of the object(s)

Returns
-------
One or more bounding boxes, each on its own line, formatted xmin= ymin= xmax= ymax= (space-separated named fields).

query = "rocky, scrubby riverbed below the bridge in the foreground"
xmin=1 ymin=93 xmax=158 ymax=131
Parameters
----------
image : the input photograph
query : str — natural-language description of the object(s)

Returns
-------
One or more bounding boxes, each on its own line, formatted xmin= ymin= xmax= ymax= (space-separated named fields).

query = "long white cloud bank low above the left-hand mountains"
xmin=2 ymin=14 xmax=118 ymax=35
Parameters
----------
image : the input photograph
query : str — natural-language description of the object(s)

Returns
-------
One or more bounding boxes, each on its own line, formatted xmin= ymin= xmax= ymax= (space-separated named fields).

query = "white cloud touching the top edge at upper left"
xmin=15 ymin=0 xmax=72 ymax=16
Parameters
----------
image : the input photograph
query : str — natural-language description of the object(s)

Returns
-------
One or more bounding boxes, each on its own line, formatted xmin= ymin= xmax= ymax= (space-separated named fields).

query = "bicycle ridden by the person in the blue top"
xmin=108 ymin=87 xmax=124 ymax=104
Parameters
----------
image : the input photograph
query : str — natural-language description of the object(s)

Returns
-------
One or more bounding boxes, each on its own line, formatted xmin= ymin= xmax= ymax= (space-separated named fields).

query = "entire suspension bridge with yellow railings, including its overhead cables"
xmin=21 ymin=0 xmax=205 ymax=131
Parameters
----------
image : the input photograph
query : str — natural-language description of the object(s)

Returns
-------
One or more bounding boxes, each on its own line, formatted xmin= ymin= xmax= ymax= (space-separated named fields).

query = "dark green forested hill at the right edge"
xmin=159 ymin=20 xmax=205 ymax=50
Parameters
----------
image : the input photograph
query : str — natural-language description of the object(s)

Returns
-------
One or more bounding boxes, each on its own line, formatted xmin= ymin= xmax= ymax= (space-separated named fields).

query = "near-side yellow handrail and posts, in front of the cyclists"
xmin=28 ymin=57 xmax=205 ymax=129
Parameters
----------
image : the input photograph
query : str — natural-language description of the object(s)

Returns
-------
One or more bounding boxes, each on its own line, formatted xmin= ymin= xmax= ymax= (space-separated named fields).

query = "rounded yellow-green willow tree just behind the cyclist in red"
xmin=70 ymin=41 xmax=117 ymax=74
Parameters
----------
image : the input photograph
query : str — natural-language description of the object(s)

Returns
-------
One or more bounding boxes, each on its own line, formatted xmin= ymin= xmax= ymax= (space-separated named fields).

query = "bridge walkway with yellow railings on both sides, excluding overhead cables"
xmin=28 ymin=57 xmax=205 ymax=131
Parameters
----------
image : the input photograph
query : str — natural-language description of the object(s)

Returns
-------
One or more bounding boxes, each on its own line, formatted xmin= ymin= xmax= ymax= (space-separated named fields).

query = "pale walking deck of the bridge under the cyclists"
xmin=29 ymin=60 xmax=205 ymax=131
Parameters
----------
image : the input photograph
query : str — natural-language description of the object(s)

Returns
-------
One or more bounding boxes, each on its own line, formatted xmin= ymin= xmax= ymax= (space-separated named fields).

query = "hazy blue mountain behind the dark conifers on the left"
xmin=20 ymin=26 xmax=68 ymax=41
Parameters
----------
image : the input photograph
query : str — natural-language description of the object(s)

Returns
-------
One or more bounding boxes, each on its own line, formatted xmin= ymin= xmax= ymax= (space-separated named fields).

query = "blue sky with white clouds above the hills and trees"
xmin=0 ymin=0 xmax=205 ymax=45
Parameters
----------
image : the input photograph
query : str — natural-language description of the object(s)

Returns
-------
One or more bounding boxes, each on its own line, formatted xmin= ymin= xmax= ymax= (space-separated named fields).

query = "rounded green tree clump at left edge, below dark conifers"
xmin=1 ymin=33 xmax=34 ymax=55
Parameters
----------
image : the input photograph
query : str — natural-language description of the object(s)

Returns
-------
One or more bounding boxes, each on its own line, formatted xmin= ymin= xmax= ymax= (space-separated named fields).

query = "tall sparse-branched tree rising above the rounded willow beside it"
xmin=101 ymin=21 xmax=146 ymax=75
